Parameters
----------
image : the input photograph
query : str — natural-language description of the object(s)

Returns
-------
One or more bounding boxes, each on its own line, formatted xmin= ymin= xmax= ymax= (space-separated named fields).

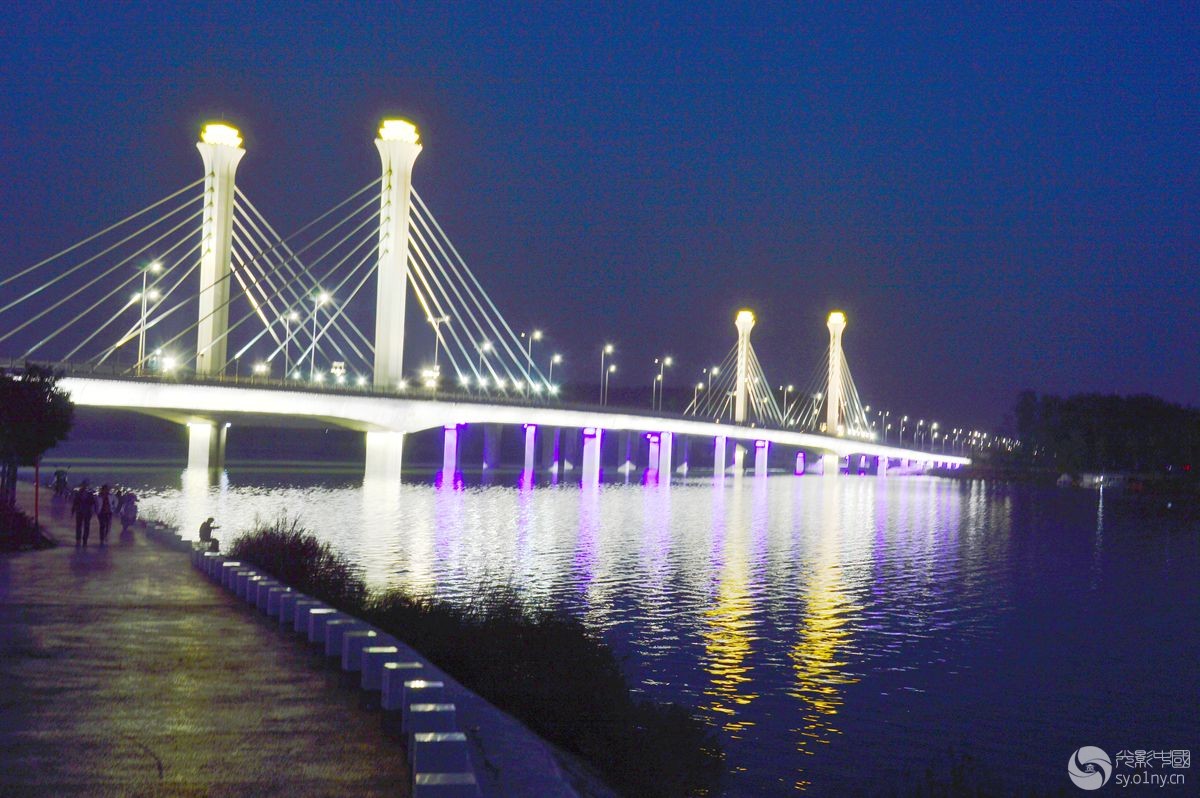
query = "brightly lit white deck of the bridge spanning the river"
xmin=59 ymin=377 xmax=971 ymax=466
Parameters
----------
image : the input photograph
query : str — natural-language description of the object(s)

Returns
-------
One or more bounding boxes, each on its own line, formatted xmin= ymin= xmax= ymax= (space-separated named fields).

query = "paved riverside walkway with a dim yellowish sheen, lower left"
xmin=0 ymin=486 xmax=409 ymax=796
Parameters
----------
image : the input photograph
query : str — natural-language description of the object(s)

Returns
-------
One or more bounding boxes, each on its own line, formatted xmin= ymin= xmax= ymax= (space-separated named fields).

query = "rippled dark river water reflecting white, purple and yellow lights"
xmin=75 ymin=469 xmax=1200 ymax=796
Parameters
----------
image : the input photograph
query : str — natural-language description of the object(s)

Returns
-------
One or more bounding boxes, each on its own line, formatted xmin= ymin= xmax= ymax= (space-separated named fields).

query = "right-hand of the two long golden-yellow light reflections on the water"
xmin=788 ymin=480 xmax=859 ymax=791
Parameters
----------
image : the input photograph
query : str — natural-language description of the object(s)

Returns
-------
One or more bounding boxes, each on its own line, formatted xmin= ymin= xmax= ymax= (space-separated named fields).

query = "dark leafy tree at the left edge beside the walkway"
xmin=0 ymin=362 xmax=74 ymax=526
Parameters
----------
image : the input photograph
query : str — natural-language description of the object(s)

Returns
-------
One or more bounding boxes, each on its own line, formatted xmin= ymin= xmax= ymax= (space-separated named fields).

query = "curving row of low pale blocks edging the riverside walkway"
xmin=192 ymin=550 xmax=480 ymax=798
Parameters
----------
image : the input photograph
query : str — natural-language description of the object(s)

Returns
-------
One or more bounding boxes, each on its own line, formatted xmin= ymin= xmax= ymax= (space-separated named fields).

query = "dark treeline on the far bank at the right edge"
xmin=1014 ymin=391 xmax=1200 ymax=474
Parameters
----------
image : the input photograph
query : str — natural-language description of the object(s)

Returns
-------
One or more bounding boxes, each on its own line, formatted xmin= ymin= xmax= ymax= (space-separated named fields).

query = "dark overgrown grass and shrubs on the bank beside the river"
xmin=229 ymin=517 xmax=724 ymax=797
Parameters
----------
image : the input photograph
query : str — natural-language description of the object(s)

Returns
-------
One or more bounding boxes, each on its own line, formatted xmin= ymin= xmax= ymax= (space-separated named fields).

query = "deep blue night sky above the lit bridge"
xmin=0 ymin=2 xmax=1200 ymax=430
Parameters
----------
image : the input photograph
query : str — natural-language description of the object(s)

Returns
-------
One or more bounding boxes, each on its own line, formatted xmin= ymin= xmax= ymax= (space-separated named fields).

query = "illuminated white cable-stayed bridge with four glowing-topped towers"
xmin=0 ymin=120 xmax=970 ymax=482
